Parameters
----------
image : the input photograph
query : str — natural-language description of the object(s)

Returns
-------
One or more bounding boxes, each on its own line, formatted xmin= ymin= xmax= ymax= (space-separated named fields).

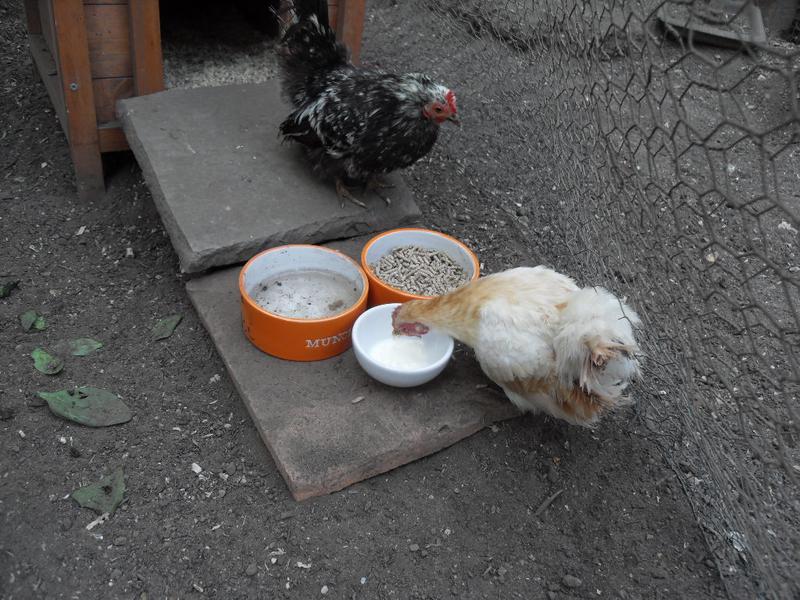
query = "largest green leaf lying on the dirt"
xmin=37 ymin=386 xmax=133 ymax=427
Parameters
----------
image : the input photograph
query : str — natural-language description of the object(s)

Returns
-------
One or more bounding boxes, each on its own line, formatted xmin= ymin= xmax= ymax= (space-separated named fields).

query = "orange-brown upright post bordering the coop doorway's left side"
xmin=128 ymin=0 xmax=164 ymax=96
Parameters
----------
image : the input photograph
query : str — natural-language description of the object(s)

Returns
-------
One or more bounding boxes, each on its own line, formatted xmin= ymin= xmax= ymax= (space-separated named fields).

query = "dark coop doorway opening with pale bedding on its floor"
xmin=161 ymin=0 xmax=278 ymax=88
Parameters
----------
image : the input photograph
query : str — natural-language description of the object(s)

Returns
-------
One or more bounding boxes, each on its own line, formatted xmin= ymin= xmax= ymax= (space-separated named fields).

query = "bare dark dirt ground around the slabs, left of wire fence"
xmin=0 ymin=0 xmax=723 ymax=599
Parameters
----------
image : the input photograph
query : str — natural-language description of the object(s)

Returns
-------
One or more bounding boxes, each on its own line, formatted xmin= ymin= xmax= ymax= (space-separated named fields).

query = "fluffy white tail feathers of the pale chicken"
xmin=553 ymin=288 xmax=640 ymax=407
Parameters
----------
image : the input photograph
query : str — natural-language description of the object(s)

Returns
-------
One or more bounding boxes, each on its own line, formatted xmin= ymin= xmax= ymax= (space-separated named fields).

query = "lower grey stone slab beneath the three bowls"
xmin=187 ymin=240 xmax=518 ymax=500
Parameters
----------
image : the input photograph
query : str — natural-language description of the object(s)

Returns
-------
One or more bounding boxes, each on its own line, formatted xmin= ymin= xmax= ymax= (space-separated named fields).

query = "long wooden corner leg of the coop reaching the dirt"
xmin=53 ymin=0 xmax=105 ymax=199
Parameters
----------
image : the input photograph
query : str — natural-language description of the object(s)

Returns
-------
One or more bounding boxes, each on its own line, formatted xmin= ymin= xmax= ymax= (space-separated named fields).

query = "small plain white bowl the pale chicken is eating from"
xmin=352 ymin=303 xmax=453 ymax=387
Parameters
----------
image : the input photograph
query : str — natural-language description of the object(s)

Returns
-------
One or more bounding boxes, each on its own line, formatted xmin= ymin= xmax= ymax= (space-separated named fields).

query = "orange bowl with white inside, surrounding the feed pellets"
xmin=361 ymin=228 xmax=481 ymax=306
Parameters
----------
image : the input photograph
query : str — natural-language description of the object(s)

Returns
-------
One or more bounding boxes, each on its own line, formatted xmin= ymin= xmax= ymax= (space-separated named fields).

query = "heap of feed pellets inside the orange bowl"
xmin=369 ymin=245 xmax=469 ymax=296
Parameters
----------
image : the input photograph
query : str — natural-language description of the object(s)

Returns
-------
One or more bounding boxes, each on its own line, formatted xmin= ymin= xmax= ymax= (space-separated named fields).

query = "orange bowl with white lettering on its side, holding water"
xmin=239 ymin=244 xmax=369 ymax=361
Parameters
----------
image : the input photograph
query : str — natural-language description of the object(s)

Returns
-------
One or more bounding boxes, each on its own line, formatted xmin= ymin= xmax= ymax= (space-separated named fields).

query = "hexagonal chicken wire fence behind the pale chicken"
xmin=404 ymin=0 xmax=800 ymax=598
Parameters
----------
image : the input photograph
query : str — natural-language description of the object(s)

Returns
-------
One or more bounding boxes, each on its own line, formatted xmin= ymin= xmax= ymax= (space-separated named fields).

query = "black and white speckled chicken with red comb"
xmin=279 ymin=0 xmax=458 ymax=206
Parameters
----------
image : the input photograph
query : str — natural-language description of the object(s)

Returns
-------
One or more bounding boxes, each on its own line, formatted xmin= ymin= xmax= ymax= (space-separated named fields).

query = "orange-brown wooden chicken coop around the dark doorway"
xmin=25 ymin=0 xmax=365 ymax=198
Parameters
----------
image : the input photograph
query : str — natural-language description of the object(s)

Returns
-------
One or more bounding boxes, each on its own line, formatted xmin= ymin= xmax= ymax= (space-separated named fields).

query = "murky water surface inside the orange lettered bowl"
xmin=251 ymin=269 xmax=361 ymax=319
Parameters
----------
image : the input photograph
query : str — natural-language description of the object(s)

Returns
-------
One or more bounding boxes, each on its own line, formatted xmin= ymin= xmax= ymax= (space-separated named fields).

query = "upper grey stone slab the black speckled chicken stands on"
xmin=118 ymin=81 xmax=420 ymax=273
